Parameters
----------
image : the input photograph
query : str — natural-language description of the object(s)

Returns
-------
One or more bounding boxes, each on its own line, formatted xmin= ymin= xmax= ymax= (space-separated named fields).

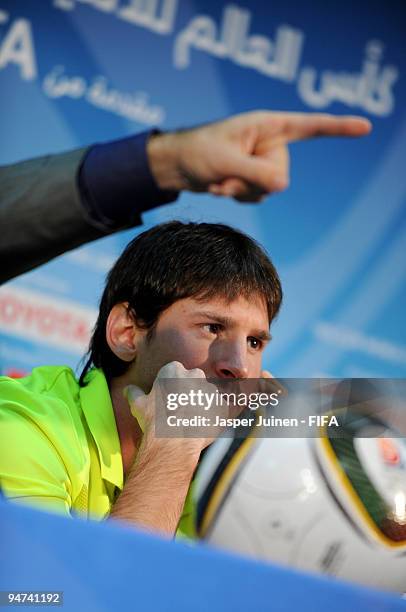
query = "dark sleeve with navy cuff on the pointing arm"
xmin=0 ymin=134 xmax=177 ymax=283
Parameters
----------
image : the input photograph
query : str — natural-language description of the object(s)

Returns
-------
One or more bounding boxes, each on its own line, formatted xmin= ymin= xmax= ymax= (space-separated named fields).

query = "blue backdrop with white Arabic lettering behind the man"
xmin=0 ymin=0 xmax=406 ymax=377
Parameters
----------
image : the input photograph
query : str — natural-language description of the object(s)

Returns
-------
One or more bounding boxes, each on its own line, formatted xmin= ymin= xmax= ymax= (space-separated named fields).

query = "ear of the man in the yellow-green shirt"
xmin=106 ymin=302 xmax=141 ymax=362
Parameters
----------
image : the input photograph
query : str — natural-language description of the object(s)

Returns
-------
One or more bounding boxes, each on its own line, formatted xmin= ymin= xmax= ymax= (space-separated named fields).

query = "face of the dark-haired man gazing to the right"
xmin=128 ymin=295 xmax=270 ymax=392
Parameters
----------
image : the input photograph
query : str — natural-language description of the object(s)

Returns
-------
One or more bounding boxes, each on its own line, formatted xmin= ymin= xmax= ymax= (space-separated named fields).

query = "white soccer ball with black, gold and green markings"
xmin=195 ymin=417 xmax=406 ymax=592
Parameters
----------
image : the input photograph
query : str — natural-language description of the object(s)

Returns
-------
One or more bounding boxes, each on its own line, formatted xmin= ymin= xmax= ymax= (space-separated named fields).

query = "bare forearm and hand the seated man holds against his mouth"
xmin=110 ymin=361 xmax=211 ymax=536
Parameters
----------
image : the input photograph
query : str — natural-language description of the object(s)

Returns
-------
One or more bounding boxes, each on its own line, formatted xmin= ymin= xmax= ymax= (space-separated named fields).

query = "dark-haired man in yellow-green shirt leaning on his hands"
xmin=0 ymin=222 xmax=282 ymax=534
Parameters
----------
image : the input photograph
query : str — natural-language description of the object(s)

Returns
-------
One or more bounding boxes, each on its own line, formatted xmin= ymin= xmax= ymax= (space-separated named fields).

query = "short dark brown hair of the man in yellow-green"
xmin=80 ymin=221 xmax=282 ymax=384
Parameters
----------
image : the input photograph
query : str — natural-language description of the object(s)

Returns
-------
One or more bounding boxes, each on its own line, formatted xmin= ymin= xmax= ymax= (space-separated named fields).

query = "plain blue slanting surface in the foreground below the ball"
xmin=0 ymin=502 xmax=406 ymax=612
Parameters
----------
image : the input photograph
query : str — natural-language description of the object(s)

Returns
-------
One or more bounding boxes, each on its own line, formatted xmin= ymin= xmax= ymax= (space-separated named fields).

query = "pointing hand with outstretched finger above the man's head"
xmin=148 ymin=111 xmax=371 ymax=202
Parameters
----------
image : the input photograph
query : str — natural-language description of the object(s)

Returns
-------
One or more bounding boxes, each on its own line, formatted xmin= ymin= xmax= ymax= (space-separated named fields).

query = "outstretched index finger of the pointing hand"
xmin=280 ymin=113 xmax=372 ymax=141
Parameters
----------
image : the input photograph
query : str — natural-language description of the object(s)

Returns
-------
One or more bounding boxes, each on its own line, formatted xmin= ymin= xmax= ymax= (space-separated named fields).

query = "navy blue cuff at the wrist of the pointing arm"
xmin=78 ymin=130 xmax=179 ymax=230
